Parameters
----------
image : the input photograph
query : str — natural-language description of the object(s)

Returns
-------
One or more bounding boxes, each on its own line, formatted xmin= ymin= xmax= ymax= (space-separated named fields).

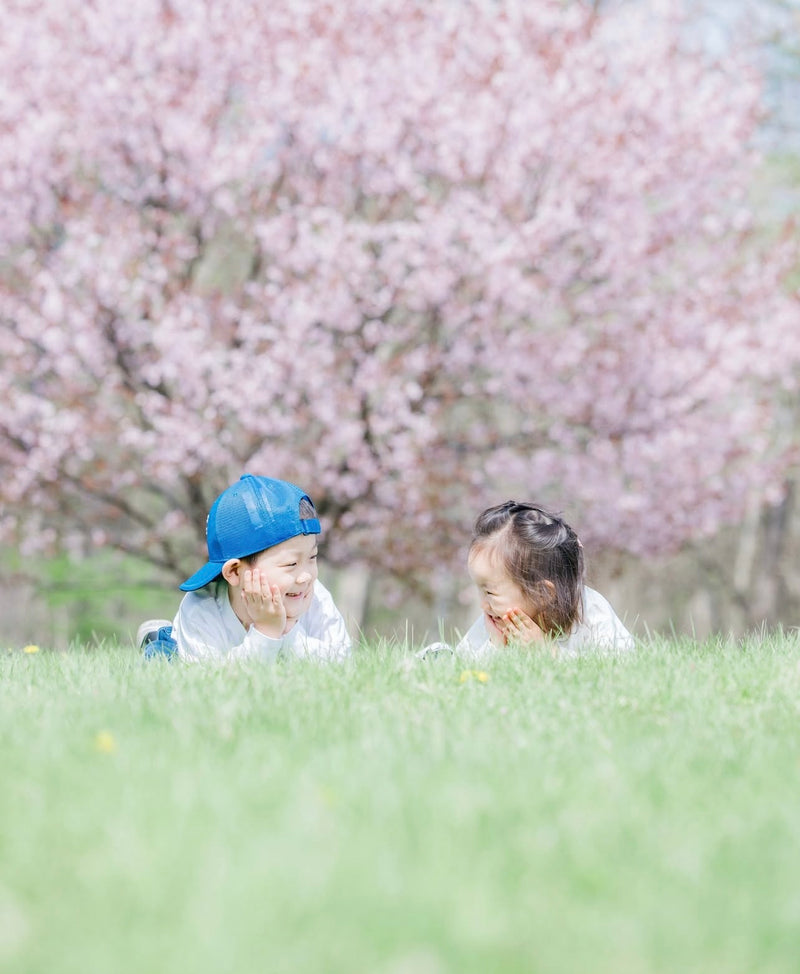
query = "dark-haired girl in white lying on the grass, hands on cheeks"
xmin=456 ymin=501 xmax=633 ymax=656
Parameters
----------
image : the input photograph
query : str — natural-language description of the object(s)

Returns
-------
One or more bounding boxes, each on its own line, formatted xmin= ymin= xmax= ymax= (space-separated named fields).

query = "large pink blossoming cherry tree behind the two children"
xmin=0 ymin=0 xmax=800 ymax=587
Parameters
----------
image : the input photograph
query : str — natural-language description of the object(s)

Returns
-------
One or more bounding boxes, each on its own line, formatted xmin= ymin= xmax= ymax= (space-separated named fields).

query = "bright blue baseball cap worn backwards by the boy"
xmin=180 ymin=473 xmax=320 ymax=592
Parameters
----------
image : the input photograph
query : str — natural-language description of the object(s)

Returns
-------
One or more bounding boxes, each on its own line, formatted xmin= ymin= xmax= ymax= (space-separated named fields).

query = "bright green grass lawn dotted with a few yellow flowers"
xmin=0 ymin=635 xmax=800 ymax=974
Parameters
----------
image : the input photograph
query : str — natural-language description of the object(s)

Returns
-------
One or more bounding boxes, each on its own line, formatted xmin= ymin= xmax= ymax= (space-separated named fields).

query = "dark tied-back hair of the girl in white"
xmin=469 ymin=501 xmax=584 ymax=635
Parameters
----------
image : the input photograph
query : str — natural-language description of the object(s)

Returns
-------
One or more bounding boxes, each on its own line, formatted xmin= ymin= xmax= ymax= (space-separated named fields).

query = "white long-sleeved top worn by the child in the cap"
xmin=172 ymin=578 xmax=351 ymax=661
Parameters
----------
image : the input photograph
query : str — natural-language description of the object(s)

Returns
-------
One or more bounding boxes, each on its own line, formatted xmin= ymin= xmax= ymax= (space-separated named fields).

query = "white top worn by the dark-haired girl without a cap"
xmin=455 ymin=586 xmax=634 ymax=657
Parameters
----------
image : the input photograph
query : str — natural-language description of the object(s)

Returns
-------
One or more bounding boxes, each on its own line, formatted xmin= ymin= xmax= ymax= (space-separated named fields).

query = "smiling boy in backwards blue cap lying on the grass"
xmin=140 ymin=474 xmax=351 ymax=660
